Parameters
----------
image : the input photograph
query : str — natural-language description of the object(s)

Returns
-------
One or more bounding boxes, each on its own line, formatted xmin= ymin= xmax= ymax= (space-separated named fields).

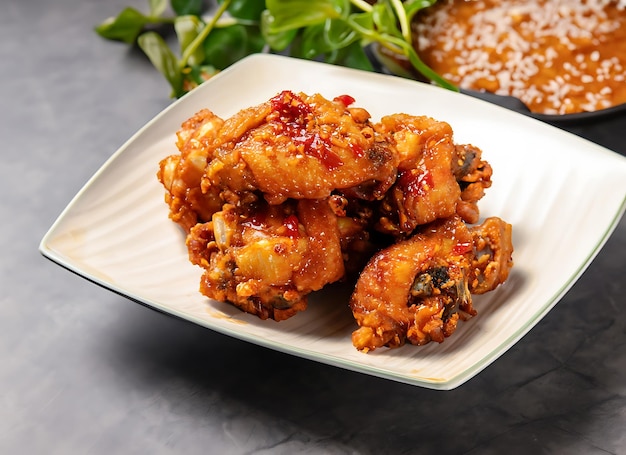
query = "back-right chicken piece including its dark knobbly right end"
xmin=374 ymin=114 xmax=492 ymax=237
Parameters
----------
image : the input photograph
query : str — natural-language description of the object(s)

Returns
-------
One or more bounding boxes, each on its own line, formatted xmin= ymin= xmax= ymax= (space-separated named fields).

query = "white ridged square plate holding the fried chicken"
xmin=40 ymin=54 xmax=626 ymax=389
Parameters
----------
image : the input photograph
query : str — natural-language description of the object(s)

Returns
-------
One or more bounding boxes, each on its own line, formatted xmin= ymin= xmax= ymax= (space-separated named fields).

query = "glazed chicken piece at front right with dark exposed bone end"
xmin=350 ymin=217 xmax=474 ymax=351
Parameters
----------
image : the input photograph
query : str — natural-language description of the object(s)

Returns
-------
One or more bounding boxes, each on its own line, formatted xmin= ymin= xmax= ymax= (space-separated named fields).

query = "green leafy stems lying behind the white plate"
xmin=95 ymin=0 xmax=458 ymax=97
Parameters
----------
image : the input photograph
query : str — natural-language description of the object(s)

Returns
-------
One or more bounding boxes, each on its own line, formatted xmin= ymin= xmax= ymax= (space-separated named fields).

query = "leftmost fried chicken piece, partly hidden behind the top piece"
xmin=157 ymin=109 xmax=224 ymax=232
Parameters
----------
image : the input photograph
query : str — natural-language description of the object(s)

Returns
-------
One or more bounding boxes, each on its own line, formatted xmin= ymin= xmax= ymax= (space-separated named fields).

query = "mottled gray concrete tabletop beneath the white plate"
xmin=0 ymin=0 xmax=626 ymax=455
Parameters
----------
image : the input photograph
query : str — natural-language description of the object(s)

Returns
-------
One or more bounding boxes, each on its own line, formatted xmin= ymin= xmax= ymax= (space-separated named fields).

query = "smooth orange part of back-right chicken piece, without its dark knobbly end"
xmin=375 ymin=114 xmax=461 ymax=237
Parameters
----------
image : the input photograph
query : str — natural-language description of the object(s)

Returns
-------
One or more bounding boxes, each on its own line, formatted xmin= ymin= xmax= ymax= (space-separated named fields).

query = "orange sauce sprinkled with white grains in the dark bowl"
xmin=414 ymin=0 xmax=626 ymax=114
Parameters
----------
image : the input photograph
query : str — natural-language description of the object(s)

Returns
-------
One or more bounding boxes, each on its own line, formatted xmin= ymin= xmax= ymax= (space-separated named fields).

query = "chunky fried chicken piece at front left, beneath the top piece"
xmin=187 ymin=199 xmax=344 ymax=321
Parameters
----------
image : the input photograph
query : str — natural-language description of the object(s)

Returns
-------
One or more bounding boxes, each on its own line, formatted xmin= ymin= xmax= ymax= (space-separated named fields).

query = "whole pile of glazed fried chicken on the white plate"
xmin=157 ymin=91 xmax=513 ymax=352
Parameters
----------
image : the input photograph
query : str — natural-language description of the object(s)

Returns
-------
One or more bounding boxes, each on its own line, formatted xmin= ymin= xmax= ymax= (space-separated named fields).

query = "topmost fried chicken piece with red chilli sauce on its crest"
xmin=204 ymin=91 xmax=397 ymax=204
